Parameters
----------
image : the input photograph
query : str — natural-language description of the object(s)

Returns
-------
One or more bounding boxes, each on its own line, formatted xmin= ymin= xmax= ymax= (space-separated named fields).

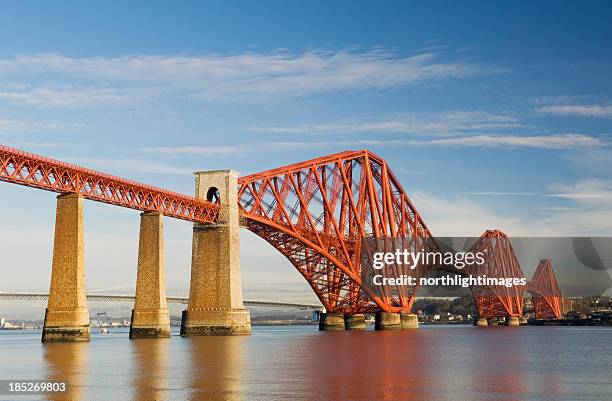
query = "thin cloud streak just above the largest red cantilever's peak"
xmin=248 ymin=110 xmax=527 ymax=135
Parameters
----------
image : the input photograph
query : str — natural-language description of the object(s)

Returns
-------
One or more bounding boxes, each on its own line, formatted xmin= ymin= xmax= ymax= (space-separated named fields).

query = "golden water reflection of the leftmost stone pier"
xmin=43 ymin=342 xmax=89 ymax=401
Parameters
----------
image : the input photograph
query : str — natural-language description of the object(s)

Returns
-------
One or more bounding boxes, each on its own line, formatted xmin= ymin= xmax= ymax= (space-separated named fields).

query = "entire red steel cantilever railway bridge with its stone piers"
xmin=0 ymin=146 xmax=564 ymax=342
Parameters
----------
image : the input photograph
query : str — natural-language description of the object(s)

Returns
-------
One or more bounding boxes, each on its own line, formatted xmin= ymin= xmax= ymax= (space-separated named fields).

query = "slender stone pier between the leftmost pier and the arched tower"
xmin=130 ymin=212 xmax=170 ymax=338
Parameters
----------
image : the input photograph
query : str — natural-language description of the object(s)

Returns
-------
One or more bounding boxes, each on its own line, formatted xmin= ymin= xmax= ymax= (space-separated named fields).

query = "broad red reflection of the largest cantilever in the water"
xmin=304 ymin=330 xmax=435 ymax=401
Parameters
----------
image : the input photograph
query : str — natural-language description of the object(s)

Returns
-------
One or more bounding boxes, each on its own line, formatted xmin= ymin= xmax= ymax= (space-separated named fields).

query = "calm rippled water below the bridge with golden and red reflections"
xmin=0 ymin=326 xmax=612 ymax=401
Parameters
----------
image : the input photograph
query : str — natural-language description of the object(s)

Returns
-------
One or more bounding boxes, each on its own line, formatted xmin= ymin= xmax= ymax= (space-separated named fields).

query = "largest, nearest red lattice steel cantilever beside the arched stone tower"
xmin=238 ymin=150 xmax=431 ymax=312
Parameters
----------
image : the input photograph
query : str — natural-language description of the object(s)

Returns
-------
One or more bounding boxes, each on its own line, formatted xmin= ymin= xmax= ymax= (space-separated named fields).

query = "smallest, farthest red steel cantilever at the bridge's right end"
xmin=527 ymin=259 xmax=563 ymax=319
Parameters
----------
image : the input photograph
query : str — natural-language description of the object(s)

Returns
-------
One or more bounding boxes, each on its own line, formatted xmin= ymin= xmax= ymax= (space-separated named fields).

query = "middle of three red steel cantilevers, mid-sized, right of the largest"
xmin=465 ymin=230 xmax=524 ymax=318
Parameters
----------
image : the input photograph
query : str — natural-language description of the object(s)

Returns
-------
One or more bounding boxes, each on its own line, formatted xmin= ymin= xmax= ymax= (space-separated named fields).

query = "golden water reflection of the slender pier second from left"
xmin=133 ymin=338 xmax=170 ymax=401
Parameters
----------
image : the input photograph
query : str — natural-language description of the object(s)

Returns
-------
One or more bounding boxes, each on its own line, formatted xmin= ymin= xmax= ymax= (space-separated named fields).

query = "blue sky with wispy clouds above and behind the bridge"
xmin=0 ymin=1 xmax=612 ymax=300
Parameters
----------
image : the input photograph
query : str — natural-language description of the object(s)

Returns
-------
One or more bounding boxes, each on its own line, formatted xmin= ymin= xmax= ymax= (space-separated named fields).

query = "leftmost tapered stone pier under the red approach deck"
xmin=42 ymin=194 xmax=89 ymax=342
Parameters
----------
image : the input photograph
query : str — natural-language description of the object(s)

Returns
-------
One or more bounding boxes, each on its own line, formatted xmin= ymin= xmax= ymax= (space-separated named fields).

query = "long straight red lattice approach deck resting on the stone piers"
xmin=0 ymin=146 xmax=219 ymax=223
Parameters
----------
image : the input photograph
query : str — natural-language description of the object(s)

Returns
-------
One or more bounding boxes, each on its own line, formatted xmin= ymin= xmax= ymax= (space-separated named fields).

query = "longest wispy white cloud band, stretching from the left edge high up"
xmin=0 ymin=50 xmax=492 ymax=107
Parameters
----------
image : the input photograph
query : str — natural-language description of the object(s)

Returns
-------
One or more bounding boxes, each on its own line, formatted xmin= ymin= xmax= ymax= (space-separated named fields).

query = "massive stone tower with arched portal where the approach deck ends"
xmin=181 ymin=170 xmax=251 ymax=336
